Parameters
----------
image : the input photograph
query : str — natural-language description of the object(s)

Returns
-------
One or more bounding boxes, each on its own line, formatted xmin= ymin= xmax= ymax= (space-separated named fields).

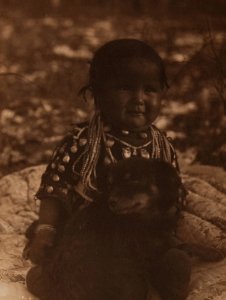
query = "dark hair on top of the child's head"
xmin=79 ymin=39 xmax=169 ymax=98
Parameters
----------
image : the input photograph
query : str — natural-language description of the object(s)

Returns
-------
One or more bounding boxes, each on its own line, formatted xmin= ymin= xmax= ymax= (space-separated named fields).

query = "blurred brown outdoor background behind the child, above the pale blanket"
xmin=0 ymin=0 xmax=226 ymax=175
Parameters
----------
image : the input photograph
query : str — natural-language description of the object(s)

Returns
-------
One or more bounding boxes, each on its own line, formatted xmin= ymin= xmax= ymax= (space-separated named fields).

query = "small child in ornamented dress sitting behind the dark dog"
xmin=24 ymin=39 xmax=182 ymax=298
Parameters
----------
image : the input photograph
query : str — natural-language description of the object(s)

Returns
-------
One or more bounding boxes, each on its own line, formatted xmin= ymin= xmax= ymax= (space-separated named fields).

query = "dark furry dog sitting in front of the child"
xmin=28 ymin=158 xmax=191 ymax=300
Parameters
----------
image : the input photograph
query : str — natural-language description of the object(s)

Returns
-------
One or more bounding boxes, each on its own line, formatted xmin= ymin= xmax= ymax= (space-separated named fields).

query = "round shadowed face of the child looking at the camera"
xmin=97 ymin=59 xmax=162 ymax=129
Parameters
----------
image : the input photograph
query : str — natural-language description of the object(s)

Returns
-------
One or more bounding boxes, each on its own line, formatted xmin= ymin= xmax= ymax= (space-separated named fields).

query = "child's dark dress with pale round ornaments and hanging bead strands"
xmin=36 ymin=114 xmax=178 ymax=210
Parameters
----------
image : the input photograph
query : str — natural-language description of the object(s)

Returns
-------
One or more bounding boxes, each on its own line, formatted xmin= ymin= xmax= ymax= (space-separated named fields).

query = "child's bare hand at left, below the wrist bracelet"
xmin=23 ymin=230 xmax=55 ymax=264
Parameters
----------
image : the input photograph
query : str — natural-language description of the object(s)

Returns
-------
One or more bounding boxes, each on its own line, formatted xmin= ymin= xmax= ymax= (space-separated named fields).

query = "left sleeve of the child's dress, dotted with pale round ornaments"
xmin=36 ymin=127 xmax=87 ymax=206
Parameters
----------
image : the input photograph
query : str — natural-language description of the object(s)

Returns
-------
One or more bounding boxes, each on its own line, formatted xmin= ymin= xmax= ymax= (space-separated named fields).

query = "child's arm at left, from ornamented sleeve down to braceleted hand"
xmin=24 ymin=128 xmax=89 ymax=263
